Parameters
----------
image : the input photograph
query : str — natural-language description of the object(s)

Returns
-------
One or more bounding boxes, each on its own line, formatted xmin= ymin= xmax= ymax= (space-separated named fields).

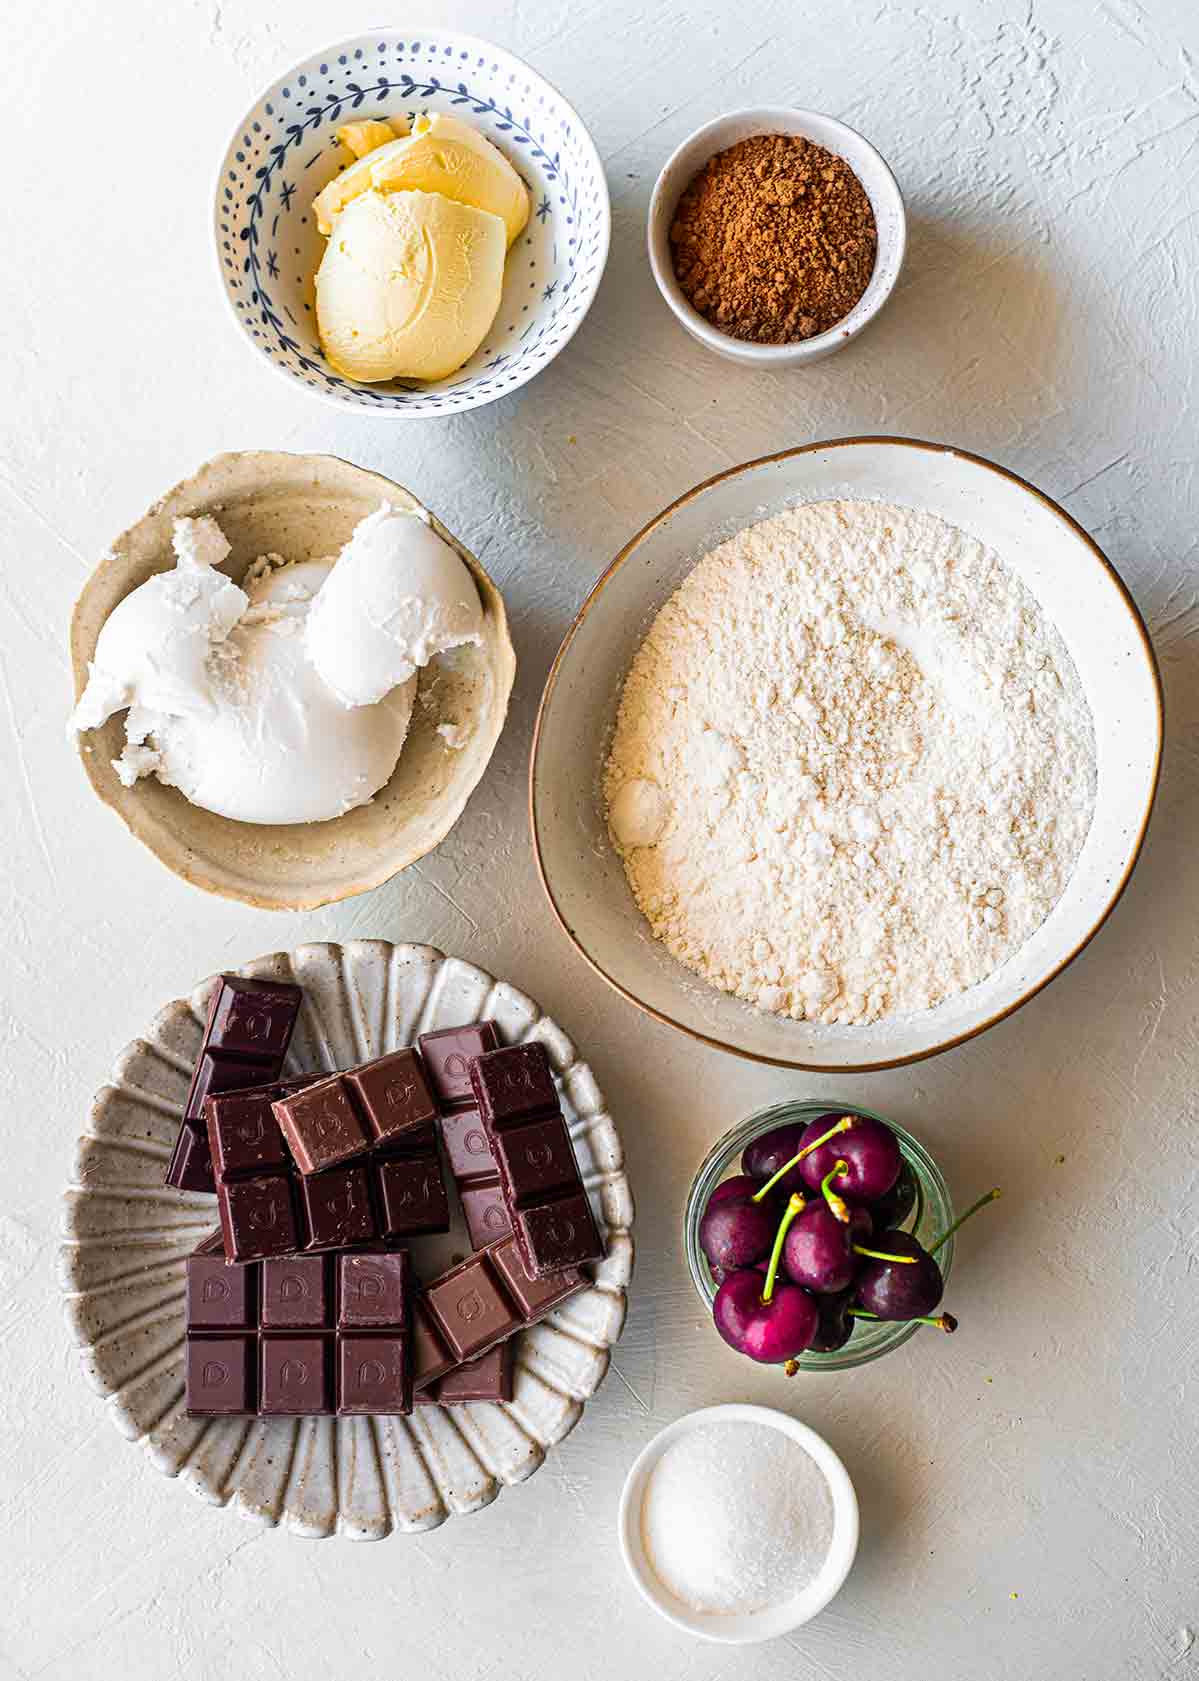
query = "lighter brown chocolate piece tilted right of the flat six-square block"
xmin=412 ymin=1234 xmax=587 ymax=1392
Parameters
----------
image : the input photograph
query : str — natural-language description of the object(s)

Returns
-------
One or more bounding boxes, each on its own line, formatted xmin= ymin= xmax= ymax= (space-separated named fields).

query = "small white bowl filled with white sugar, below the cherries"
xmin=619 ymin=1404 xmax=858 ymax=1646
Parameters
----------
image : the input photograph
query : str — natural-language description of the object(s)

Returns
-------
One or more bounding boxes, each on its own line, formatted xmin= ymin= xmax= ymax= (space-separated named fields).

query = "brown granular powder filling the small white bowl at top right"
xmin=671 ymin=134 xmax=878 ymax=345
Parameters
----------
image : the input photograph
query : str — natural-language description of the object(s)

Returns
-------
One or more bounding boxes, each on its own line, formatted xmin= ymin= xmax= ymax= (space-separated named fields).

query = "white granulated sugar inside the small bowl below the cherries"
xmin=641 ymin=1424 xmax=832 ymax=1614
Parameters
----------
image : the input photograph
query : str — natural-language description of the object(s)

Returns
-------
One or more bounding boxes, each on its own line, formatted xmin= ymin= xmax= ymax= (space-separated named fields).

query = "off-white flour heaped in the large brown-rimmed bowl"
xmin=604 ymin=501 xmax=1096 ymax=1022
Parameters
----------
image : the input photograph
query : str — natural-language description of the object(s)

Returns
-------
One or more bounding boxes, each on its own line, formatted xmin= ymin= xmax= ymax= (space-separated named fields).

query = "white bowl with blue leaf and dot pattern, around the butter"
xmin=214 ymin=29 xmax=612 ymax=415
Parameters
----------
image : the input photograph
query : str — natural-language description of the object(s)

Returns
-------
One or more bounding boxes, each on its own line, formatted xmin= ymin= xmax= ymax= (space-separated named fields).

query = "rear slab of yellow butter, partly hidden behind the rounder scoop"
xmin=313 ymin=111 xmax=530 ymax=245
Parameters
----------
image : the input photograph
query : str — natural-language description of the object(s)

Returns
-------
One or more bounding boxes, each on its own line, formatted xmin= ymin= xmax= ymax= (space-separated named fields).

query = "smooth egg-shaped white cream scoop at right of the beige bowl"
xmin=306 ymin=503 xmax=483 ymax=706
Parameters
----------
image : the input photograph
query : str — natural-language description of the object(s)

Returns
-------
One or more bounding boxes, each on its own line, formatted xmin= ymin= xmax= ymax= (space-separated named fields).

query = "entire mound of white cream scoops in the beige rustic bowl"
xmin=71 ymin=504 xmax=483 ymax=824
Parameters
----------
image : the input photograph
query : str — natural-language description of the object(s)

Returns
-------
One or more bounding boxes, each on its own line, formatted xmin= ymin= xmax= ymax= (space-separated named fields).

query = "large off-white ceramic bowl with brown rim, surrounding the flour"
xmin=530 ymin=437 xmax=1162 ymax=1072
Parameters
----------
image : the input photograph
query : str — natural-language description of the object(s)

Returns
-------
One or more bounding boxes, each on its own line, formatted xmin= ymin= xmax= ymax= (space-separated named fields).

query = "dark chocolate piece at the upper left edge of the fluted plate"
xmin=166 ymin=975 xmax=304 ymax=1190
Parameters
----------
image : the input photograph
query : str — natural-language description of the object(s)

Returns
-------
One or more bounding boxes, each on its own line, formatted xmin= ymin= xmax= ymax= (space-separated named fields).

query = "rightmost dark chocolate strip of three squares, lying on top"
xmin=471 ymin=1041 xmax=604 ymax=1278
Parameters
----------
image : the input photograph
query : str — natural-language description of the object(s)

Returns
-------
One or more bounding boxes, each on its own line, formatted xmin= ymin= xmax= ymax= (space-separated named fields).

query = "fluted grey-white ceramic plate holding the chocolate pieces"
xmin=62 ymin=940 xmax=632 ymax=1540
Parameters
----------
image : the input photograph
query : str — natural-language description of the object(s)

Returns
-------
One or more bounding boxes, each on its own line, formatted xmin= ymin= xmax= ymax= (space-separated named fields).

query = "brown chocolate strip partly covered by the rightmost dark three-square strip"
xmin=417 ymin=1022 xmax=511 ymax=1249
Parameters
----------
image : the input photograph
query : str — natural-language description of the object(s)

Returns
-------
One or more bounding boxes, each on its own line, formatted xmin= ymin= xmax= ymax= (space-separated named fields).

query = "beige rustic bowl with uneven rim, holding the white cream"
xmin=71 ymin=451 xmax=516 ymax=911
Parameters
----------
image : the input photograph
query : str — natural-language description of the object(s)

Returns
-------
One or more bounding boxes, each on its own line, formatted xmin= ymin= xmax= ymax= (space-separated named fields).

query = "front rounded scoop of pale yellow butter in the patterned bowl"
xmin=316 ymin=188 xmax=506 ymax=382
